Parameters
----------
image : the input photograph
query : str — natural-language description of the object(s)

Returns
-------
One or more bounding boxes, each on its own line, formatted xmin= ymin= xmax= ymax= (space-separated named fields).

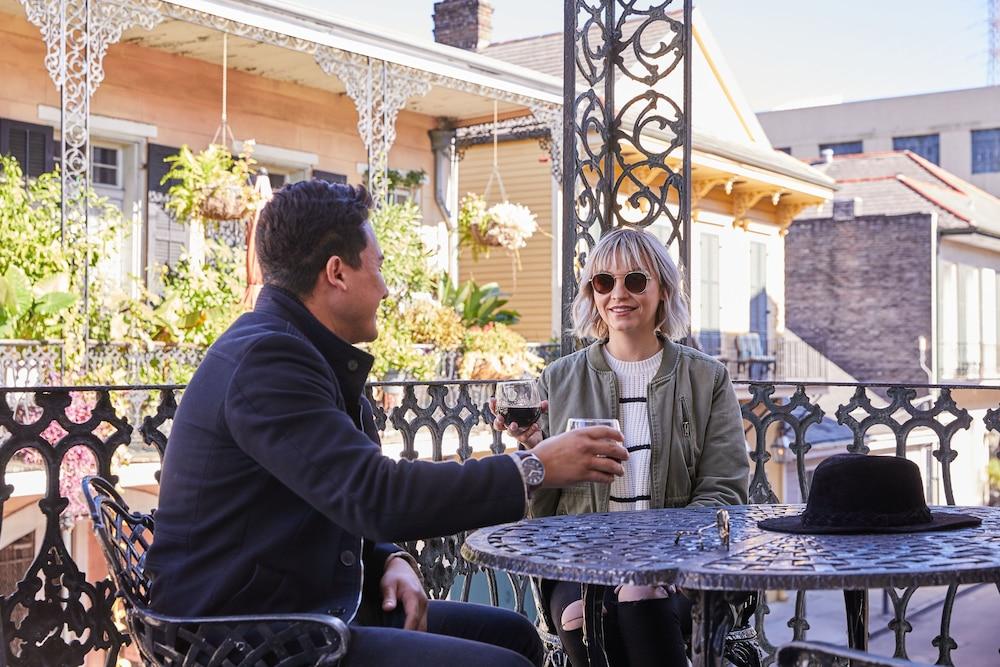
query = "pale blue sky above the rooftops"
xmin=290 ymin=0 xmax=988 ymax=111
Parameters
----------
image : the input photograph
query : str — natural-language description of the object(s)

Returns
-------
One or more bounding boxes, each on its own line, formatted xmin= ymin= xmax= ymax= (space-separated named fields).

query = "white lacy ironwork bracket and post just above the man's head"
xmin=316 ymin=47 xmax=431 ymax=205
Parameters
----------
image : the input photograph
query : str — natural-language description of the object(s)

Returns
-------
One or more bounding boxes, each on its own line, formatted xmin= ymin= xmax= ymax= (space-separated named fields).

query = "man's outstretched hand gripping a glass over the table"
xmin=532 ymin=426 xmax=628 ymax=488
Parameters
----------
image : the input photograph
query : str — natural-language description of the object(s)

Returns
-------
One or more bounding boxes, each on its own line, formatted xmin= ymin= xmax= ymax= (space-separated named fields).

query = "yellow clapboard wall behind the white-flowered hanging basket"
xmin=458 ymin=139 xmax=558 ymax=342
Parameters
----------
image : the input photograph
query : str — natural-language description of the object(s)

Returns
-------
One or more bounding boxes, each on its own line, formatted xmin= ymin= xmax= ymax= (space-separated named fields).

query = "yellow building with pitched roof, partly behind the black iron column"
xmin=435 ymin=0 xmax=833 ymax=370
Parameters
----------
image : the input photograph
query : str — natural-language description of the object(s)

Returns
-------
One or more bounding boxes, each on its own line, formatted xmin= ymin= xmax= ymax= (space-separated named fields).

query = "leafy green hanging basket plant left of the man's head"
xmin=160 ymin=141 xmax=260 ymax=226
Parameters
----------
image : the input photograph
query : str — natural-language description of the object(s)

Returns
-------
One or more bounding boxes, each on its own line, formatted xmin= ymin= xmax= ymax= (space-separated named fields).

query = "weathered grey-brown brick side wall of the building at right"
xmin=785 ymin=213 xmax=934 ymax=382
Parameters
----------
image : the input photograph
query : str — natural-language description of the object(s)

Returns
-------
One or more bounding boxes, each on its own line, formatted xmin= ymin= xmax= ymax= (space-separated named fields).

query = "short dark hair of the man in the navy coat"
xmin=256 ymin=179 xmax=372 ymax=296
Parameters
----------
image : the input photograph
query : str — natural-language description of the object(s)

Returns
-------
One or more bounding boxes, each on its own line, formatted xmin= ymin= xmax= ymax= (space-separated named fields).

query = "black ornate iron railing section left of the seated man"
xmin=0 ymin=387 xmax=175 ymax=666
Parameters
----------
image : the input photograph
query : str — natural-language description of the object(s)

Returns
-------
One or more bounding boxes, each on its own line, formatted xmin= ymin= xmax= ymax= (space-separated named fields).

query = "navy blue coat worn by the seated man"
xmin=147 ymin=287 xmax=525 ymax=620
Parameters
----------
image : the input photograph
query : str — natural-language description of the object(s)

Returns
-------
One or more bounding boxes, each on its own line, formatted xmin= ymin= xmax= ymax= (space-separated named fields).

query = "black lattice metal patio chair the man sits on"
xmin=83 ymin=476 xmax=350 ymax=667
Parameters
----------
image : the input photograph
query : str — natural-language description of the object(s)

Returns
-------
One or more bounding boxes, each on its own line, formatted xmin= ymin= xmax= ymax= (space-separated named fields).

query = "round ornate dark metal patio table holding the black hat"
xmin=462 ymin=505 xmax=1000 ymax=667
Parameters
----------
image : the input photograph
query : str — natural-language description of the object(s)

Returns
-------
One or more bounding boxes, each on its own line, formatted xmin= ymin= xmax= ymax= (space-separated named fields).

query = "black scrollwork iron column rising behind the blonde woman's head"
xmin=562 ymin=0 xmax=692 ymax=354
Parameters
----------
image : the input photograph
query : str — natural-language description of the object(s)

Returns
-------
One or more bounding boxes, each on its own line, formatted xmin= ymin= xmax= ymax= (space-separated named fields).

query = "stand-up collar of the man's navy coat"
xmin=254 ymin=285 xmax=375 ymax=403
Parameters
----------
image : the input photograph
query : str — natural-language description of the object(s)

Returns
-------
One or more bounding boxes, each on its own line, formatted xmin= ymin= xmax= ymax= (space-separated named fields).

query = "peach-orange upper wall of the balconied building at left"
xmin=0 ymin=13 xmax=440 ymax=222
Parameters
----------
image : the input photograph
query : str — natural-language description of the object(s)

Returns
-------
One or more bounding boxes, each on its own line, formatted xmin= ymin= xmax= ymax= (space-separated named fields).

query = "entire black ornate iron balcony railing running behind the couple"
xmin=0 ymin=383 xmax=1000 ymax=665
